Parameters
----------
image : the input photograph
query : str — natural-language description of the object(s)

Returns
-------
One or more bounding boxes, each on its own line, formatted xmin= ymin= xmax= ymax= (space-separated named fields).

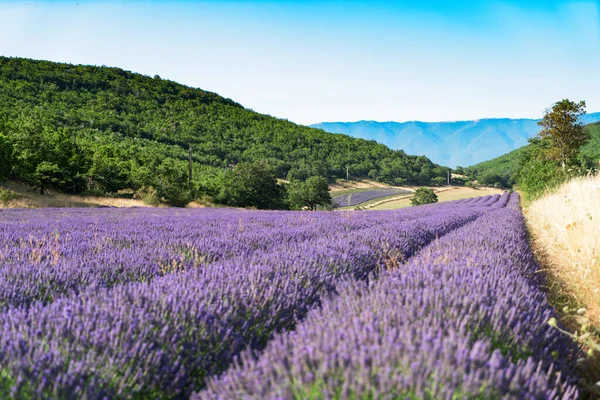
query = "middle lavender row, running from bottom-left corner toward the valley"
xmin=0 ymin=203 xmax=485 ymax=399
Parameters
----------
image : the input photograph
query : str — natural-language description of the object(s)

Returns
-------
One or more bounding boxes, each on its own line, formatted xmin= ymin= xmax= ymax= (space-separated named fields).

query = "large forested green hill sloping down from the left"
xmin=0 ymin=57 xmax=445 ymax=198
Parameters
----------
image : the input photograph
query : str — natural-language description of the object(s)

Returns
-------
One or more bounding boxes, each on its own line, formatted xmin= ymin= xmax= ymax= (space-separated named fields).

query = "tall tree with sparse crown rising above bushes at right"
xmin=538 ymin=99 xmax=590 ymax=172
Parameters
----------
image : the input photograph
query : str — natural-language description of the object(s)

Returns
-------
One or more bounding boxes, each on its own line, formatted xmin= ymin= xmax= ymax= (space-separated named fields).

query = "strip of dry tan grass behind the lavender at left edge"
xmin=0 ymin=182 xmax=148 ymax=208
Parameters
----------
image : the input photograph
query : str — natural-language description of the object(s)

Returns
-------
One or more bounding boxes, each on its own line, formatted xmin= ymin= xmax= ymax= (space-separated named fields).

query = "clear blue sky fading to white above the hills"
xmin=0 ymin=0 xmax=600 ymax=124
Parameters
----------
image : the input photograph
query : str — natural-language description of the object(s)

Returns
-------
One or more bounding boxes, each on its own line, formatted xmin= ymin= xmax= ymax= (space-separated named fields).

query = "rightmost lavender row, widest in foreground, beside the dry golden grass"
xmin=198 ymin=194 xmax=578 ymax=400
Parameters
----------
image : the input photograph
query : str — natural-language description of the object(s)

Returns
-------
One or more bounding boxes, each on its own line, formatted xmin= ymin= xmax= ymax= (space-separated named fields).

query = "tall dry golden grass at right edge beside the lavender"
xmin=524 ymin=175 xmax=600 ymax=399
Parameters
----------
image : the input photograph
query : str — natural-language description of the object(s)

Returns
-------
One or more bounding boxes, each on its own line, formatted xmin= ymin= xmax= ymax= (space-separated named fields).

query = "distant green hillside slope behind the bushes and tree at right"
xmin=465 ymin=122 xmax=600 ymax=187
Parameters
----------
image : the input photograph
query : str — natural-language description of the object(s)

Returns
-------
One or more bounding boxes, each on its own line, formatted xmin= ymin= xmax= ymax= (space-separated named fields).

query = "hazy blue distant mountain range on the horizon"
xmin=311 ymin=112 xmax=600 ymax=167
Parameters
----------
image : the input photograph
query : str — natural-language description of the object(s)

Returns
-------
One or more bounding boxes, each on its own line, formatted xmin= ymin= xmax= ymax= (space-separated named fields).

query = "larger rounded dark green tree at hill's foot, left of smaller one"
xmin=214 ymin=161 xmax=285 ymax=209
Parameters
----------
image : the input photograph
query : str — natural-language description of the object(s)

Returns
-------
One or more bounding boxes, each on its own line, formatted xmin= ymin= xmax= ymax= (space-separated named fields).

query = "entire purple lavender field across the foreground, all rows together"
xmin=0 ymin=193 xmax=578 ymax=399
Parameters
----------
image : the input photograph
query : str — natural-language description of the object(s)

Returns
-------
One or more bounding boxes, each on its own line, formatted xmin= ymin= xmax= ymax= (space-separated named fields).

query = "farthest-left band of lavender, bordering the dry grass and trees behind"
xmin=0 ymin=209 xmax=474 ymax=309
